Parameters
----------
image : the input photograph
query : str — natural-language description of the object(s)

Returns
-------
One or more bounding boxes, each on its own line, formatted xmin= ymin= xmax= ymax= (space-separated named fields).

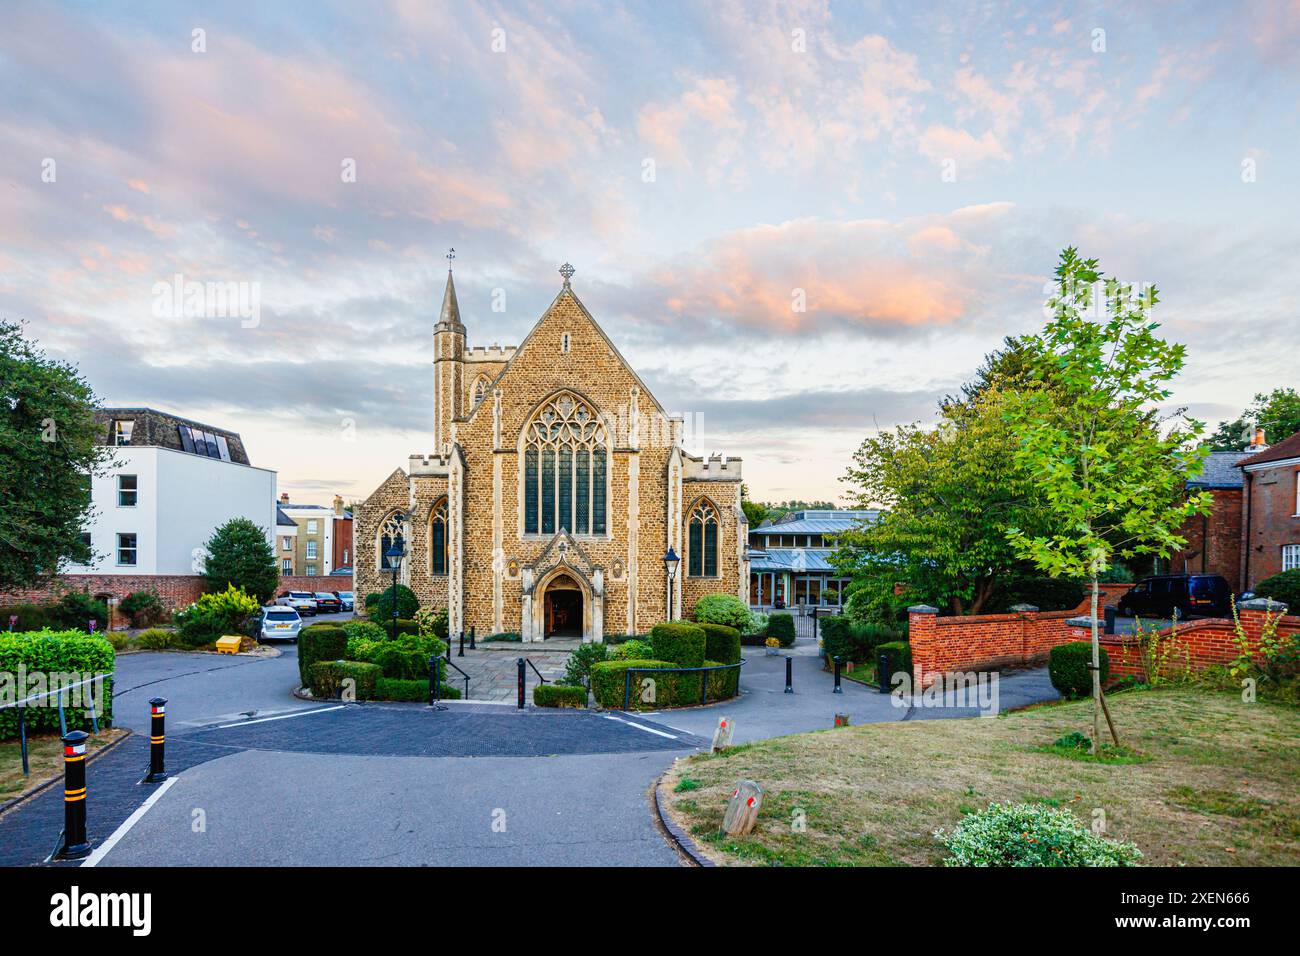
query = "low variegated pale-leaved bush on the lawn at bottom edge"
xmin=935 ymin=804 xmax=1141 ymax=866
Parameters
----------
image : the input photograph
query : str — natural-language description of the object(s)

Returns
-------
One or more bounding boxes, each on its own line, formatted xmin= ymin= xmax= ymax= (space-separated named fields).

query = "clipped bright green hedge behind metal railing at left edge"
xmin=0 ymin=630 xmax=117 ymax=740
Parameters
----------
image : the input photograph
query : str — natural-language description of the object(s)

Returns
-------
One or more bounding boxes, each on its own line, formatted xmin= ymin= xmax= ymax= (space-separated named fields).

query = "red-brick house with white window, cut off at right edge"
xmin=1236 ymin=432 xmax=1300 ymax=589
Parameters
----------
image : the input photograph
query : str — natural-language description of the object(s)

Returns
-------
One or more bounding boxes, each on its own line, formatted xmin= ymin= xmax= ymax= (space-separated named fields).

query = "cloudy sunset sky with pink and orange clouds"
xmin=0 ymin=0 xmax=1300 ymax=502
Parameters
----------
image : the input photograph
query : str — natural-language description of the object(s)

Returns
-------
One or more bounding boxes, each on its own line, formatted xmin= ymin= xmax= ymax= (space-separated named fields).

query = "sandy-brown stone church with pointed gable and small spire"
xmin=354 ymin=264 xmax=749 ymax=643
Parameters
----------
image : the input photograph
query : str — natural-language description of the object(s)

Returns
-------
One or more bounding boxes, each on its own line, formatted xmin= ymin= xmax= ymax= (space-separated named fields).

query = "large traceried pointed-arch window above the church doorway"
xmin=523 ymin=393 xmax=608 ymax=535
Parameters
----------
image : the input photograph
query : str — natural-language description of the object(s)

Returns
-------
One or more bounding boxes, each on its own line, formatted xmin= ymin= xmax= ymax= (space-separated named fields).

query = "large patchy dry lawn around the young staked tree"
xmin=663 ymin=687 xmax=1300 ymax=866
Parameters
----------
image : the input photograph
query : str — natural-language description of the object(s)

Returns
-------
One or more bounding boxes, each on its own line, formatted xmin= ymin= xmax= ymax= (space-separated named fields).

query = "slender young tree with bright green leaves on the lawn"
xmin=1006 ymin=247 xmax=1209 ymax=752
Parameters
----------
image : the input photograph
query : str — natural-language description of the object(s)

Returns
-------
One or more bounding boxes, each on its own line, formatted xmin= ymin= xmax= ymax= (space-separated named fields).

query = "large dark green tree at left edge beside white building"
xmin=0 ymin=323 xmax=112 ymax=591
